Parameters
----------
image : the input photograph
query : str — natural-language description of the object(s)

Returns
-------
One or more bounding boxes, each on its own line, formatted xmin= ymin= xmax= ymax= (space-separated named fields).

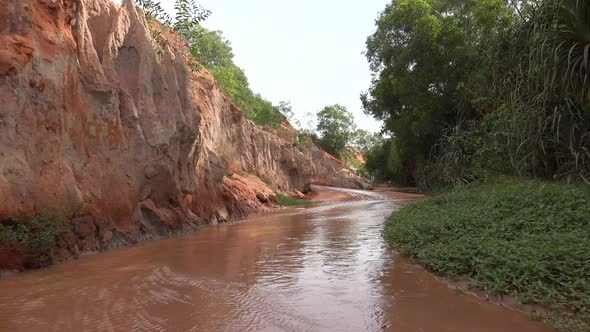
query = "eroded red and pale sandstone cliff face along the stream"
xmin=0 ymin=0 xmax=366 ymax=268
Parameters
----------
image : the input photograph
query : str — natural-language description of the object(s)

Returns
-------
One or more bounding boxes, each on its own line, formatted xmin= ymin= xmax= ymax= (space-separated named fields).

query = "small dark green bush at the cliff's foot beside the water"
xmin=0 ymin=213 xmax=66 ymax=266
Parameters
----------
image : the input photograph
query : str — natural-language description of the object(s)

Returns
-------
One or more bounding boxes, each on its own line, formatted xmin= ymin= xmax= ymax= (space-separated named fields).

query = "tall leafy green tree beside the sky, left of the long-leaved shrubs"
xmin=361 ymin=0 xmax=511 ymax=161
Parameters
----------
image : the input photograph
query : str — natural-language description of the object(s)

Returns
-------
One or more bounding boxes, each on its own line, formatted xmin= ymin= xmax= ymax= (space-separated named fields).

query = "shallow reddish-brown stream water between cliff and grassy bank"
xmin=0 ymin=191 xmax=552 ymax=332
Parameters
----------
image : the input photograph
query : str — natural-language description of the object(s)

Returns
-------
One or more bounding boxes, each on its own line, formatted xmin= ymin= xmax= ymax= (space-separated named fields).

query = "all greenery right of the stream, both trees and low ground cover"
xmin=361 ymin=0 xmax=590 ymax=330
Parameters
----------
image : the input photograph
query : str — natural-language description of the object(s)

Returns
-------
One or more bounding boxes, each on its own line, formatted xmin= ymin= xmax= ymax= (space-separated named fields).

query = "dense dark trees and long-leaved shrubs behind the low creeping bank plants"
xmin=361 ymin=0 xmax=590 ymax=190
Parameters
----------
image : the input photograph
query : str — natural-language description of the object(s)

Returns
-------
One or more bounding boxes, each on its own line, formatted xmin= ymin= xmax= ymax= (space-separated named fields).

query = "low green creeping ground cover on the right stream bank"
xmin=385 ymin=178 xmax=590 ymax=330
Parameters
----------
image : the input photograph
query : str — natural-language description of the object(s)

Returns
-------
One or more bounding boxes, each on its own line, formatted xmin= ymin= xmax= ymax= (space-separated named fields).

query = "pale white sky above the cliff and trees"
xmin=115 ymin=0 xmax=389 ymax=132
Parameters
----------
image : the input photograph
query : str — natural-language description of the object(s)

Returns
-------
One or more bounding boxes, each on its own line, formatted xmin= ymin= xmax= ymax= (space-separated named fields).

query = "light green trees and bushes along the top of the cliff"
xmin=136 ymin=0 xmax=376 ymax=160
